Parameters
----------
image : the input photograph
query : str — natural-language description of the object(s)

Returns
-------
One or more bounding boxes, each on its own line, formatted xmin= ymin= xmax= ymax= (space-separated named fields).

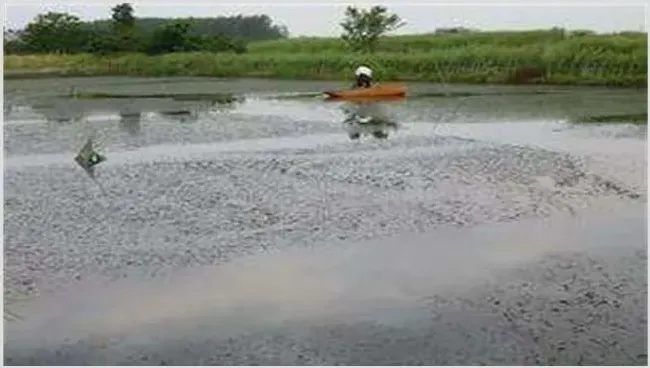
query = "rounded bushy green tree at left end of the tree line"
xmin=21 ymin=12 xmax=88 ymax=53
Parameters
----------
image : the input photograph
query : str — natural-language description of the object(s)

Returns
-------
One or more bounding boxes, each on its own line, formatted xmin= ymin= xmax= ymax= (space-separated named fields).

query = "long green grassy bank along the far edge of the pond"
xmin=4 ymin=31 xmax=647 ymax=86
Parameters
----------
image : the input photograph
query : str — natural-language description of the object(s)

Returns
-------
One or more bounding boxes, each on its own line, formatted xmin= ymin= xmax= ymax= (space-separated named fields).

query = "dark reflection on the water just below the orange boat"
xmin=342 ymin=101 xmax=399 ymax=140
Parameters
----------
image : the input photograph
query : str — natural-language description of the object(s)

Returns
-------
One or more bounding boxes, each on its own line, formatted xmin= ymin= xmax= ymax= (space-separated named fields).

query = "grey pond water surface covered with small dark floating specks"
xmin=4 ymin=78 xmax=647 ymax=364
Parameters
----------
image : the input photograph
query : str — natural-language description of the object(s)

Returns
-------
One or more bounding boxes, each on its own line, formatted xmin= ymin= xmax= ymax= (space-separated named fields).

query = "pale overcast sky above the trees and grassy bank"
xmin=5 ymin=0 xmax=646 ymax=37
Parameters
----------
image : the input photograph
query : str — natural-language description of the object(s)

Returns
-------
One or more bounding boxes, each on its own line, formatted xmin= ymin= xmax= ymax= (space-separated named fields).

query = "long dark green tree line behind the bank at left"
xmin=4 ymin=3 xmax=289 ymax=55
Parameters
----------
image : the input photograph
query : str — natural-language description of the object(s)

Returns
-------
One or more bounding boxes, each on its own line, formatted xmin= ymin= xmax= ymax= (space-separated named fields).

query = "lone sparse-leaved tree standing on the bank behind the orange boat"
xmin=340 ymin=5 xmax=406 ymax=52
